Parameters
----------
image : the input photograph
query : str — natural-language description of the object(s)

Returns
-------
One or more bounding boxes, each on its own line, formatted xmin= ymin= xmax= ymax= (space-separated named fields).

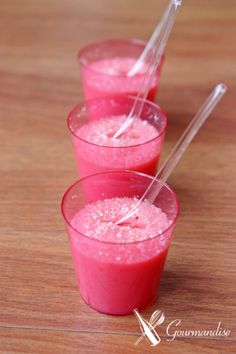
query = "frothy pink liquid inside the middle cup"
xmin=73 ymin=115 xmax=163 ymax=177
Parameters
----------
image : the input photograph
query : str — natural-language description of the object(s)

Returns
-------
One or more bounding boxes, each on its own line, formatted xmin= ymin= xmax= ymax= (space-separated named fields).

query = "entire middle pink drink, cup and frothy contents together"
xmin=68 ymin=96 xmax=167 ymax=177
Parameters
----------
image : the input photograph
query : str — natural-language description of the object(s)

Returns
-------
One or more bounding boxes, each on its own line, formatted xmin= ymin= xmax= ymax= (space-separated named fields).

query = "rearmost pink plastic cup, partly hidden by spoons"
xmin=78 ymin=39 xmax=163 ymax=101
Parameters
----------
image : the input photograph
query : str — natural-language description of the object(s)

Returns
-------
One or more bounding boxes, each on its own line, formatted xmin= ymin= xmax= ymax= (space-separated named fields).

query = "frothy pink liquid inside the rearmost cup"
xmin=81 ymin=57 xmax=160 ymax=101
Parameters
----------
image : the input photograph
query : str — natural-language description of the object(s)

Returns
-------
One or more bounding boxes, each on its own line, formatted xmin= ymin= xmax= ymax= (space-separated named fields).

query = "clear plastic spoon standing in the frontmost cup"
xmin=115 ymin=84 xmax=227 ymax=225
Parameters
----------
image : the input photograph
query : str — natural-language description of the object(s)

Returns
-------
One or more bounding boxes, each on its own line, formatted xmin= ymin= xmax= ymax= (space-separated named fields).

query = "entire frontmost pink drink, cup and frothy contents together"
xmin=62 ymin=171 xmax=179 ymax=315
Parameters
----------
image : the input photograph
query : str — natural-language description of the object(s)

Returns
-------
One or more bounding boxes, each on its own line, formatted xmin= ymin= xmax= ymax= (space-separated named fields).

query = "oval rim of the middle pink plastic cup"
xmin=67 ymin=95 xmax=168 ymax=149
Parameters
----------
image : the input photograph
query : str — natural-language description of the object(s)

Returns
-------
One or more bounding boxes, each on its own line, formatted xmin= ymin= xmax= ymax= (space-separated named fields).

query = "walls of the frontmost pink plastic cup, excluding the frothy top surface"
xmin=62 ymin=171 xmax=179 ymax=315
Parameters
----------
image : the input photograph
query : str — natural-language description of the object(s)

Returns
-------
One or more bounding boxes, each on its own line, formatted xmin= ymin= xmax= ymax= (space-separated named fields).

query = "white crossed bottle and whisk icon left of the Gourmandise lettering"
xmin=134 ymin=309 xmax=165 ymax=346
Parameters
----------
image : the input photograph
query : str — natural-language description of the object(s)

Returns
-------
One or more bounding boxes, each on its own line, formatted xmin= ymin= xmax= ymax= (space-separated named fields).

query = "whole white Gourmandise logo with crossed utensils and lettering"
xmin=134 ymin=309 xmax=230 ymax=346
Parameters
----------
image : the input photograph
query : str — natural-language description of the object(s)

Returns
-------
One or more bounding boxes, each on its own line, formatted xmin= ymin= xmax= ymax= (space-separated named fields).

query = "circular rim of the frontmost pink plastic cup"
xmin=61 ymin=170 xmax=180 ymax=245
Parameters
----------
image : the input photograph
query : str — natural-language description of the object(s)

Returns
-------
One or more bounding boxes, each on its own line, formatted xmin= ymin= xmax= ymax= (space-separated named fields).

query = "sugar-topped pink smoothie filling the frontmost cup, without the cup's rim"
xmin=70 ymin=197 xmax=173 ymax=315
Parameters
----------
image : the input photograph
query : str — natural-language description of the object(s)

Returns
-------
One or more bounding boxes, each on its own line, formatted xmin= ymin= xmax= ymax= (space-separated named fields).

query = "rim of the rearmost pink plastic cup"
xmin=77 ymin=38 xmax=164 ymax=79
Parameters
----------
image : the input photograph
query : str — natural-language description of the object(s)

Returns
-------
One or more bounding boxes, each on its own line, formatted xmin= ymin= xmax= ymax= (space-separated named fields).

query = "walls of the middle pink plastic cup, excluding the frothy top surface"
xmin=67 ymin=96 xmax=167 ymax=177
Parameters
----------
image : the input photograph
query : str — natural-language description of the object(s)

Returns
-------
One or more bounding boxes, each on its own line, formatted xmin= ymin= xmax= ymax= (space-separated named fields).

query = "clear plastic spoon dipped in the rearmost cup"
xmin=127 ymin=0 xmax=181 ymax=77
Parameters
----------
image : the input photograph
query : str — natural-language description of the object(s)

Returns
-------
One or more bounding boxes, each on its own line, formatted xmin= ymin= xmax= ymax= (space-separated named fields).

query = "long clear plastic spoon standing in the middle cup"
xmin=113 ymin=0 xmax=181 ymax=139
